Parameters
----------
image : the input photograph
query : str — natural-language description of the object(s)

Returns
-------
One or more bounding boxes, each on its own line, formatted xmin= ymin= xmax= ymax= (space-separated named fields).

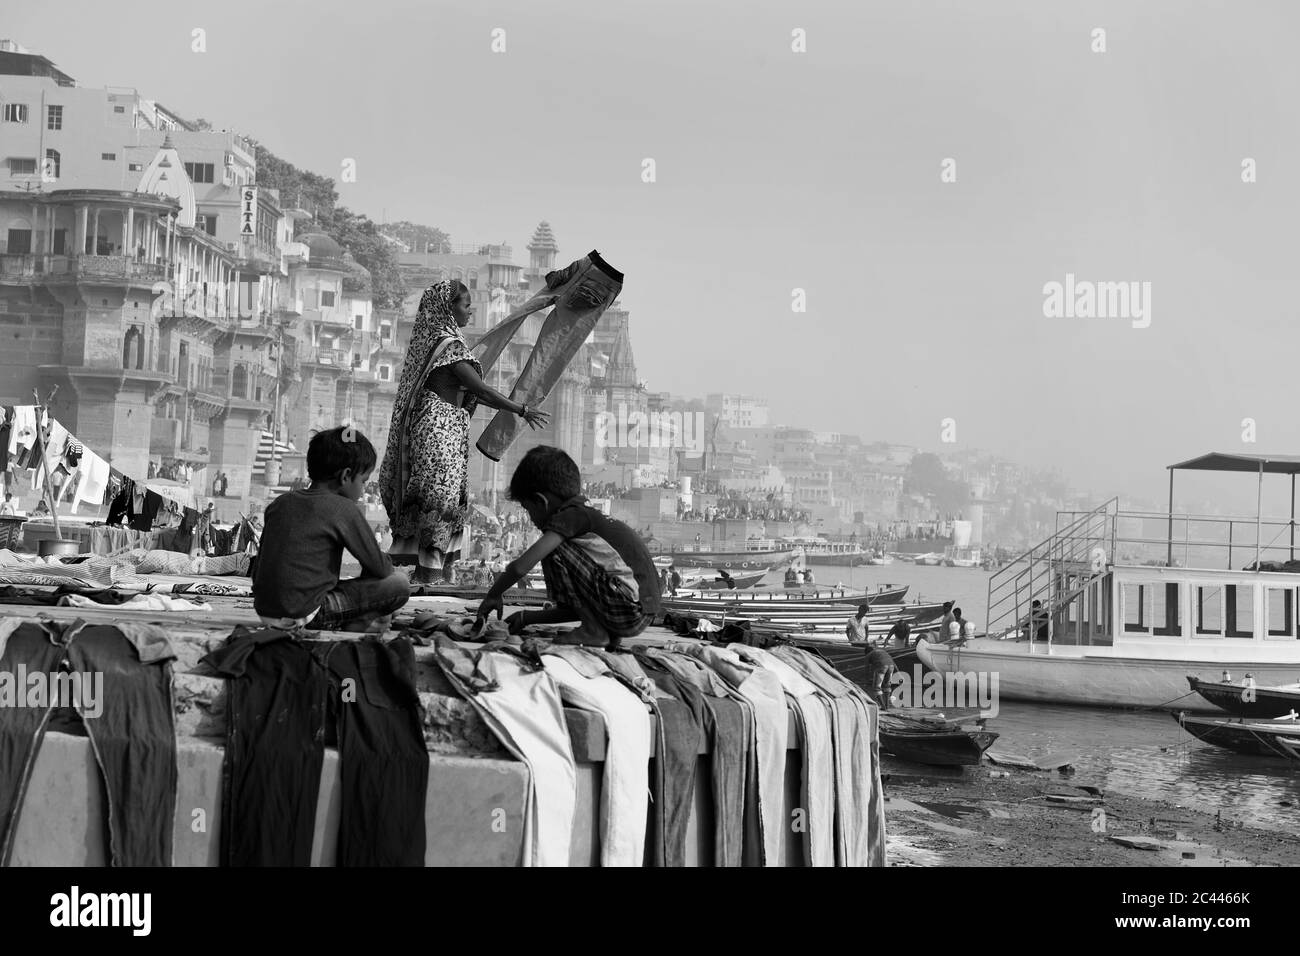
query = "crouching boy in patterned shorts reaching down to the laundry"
xmin=478 ymin=445 xmax=659 ymax=650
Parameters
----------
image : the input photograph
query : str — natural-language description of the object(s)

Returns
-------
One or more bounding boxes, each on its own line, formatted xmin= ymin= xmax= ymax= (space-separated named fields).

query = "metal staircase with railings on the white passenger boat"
xmin=984 ymin=498 xmax=1119 ymax=641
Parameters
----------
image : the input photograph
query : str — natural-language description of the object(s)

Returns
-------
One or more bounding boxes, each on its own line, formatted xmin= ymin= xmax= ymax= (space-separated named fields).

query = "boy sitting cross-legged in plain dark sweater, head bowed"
xmin=252 ymin=428 xmax=411 ymax=633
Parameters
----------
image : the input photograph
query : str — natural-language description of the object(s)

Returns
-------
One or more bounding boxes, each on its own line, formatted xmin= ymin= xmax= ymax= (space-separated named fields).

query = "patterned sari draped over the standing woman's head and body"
xmin=378 ymin=280 xmax=482 ymax=572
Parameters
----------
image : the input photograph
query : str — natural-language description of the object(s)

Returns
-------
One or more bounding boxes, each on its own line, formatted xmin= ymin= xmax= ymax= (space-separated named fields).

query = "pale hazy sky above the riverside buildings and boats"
xmin=10 ymin=0 xmax=1300 ymax=506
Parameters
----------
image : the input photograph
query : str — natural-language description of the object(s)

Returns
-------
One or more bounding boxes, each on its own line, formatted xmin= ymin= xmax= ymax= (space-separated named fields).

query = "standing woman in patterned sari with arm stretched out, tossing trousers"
xmin=380 ymin=280 xmax=547 ymax=584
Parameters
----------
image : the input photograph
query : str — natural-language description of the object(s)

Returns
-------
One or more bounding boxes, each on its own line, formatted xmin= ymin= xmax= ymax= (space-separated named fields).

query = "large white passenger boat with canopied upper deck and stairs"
xmin=918 ymin=454 xmax=1300 ymax=710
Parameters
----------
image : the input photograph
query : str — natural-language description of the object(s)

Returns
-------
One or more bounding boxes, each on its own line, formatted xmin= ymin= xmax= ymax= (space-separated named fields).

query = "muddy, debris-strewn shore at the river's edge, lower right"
xmin=881 ymin=756 xmax=1300 ymax=866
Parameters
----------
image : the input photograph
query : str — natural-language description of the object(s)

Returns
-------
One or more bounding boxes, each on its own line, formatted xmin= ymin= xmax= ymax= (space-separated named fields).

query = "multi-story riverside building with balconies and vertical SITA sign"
xmin=0 ymin=42 xmax=298 ymax=497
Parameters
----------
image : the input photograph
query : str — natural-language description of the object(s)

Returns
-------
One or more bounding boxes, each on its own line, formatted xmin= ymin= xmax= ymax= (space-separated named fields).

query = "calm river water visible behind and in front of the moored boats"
xmin=763 ymin=563 xmax=1300 ymax=834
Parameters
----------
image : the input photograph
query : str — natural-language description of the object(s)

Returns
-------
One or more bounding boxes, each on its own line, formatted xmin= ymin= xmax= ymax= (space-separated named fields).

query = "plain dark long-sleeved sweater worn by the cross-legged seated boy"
xmin=252 ymin=488 xmax=393 ymax=618
